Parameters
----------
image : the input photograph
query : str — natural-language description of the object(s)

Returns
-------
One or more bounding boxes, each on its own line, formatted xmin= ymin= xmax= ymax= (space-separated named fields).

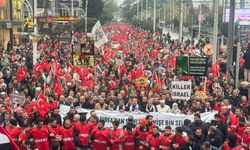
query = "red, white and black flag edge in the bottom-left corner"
xmin=0 ymin=125 xmax=20 ymax=150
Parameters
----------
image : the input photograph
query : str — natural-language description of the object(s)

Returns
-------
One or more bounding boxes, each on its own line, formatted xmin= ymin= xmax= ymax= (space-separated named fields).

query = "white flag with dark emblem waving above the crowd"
xmin=91 ymin=20 xmax=108 ymax=48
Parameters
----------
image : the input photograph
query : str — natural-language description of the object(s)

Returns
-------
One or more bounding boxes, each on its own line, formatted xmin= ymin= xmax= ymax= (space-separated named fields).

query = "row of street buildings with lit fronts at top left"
xmin=0 ymin=0 xmax=85 ymax=48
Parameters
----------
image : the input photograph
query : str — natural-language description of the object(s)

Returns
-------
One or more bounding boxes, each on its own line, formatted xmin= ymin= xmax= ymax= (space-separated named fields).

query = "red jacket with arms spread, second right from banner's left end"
xmin=75 ymin=122 xmax=95 ymax=147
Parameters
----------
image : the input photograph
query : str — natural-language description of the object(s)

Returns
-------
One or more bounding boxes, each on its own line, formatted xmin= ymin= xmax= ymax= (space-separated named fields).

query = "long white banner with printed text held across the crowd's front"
xmin=60 ymin=105 xmax=217 ymax=129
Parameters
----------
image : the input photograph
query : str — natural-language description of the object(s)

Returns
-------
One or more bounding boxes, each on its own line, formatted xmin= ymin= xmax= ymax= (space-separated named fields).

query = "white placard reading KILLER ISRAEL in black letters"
xmin=171 ymin=81 xmax=192 ymax=100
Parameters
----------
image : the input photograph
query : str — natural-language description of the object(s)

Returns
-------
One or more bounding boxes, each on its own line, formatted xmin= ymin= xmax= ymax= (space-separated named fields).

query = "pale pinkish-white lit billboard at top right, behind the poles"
xmin=223 ymin=9 xmax=250 ymax=22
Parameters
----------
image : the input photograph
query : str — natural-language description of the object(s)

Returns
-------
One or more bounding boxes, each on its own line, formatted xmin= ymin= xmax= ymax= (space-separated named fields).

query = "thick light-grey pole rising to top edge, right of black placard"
xmin=213 ymin=0 xmax=219 ymax=64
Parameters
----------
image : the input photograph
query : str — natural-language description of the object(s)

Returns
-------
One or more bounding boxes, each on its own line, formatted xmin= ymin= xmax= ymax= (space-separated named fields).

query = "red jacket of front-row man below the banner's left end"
xmin=59 ymin=126 xmax=76 ymax=150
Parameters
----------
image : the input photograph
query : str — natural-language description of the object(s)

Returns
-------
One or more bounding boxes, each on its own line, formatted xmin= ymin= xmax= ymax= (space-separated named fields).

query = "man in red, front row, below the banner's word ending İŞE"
xmin=146 ymin=126 xmax=162 ymax=149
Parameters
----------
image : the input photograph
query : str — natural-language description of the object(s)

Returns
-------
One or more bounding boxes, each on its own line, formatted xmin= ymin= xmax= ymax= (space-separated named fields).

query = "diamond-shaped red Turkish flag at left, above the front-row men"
xmin=35 ymin=92 xmax=49 ymax=118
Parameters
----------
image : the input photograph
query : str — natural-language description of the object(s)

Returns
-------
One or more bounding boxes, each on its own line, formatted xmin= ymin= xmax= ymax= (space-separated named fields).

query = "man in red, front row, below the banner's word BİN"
xmin=160 ymin=126 xmax=174 ymax=150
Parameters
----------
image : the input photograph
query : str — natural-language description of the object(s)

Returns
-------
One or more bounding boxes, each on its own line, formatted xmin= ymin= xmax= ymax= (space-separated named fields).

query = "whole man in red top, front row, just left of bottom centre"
xmin=111 ymin=121 xmax=124 ymax=150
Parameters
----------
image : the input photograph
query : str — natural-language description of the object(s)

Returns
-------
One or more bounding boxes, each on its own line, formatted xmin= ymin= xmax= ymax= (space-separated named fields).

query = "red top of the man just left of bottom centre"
xmin=111 ymin=128 xmax=124 ymax=150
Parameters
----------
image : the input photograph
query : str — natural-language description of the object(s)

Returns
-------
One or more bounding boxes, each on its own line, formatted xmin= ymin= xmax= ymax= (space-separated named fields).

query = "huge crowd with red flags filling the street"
xmin=0 ymin=23 xmax=250 ymax=150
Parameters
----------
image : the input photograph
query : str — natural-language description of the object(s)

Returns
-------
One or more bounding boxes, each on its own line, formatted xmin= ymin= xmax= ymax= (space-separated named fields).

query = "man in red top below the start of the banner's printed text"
xmin=91 ymin=120 xmax=110 ymax=150
